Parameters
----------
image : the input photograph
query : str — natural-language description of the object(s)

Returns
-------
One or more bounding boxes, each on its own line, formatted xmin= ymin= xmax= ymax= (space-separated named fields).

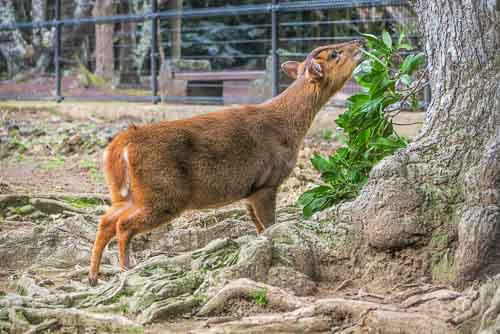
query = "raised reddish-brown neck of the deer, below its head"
xmin=265 ymin=76 xmax=332 ymax=145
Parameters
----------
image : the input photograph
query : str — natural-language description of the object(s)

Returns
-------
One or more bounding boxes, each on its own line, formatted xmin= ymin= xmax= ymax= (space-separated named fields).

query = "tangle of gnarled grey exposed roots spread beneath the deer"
xmin=0 ymin=207 xmax=500 ymax=334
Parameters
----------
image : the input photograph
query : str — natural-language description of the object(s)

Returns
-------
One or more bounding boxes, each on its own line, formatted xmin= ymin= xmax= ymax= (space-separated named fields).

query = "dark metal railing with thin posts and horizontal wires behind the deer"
xmin=0 ymin=0 xmax=414 ymax=103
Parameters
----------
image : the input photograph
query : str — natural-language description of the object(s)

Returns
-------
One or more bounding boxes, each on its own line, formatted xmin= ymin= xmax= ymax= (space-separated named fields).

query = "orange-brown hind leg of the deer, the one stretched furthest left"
xmin=89 ymin=203 xmax=126 ymax=286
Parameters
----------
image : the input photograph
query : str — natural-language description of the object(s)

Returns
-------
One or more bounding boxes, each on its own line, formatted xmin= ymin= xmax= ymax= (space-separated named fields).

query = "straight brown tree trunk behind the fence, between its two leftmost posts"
xmin=92 ymin=0 xmax=114 ymax=80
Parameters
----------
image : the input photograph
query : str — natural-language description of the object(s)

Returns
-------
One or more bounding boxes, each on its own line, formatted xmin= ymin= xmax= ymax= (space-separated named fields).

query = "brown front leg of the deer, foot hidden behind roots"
xmin=249 ymin=188 xmax=277 ymax=233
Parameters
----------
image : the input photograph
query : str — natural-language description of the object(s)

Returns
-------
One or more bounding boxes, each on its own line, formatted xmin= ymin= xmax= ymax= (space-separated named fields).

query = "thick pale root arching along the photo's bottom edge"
xmin=193 ymin=299 xmax=455 ymax=334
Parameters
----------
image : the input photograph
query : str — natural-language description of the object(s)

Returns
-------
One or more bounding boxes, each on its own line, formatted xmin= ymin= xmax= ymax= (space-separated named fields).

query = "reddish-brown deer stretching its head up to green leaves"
xmin=89 ymin=41 xmax=362 ymax=286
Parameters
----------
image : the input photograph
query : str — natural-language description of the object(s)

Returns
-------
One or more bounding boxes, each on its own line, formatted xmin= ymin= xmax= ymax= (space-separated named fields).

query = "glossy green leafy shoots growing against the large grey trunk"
xmin=299 ymin=31 xmax=424 ymax=217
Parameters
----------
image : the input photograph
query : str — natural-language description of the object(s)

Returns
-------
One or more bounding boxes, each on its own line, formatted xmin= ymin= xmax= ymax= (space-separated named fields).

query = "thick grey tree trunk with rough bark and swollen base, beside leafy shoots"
xmin=338 ymin=0 xmax=500 ymax=284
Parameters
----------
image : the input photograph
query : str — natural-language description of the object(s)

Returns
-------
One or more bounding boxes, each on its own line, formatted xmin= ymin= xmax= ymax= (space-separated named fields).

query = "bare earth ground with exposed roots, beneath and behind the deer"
xmin=0 ymin=103 xmax=500 ymax=333
